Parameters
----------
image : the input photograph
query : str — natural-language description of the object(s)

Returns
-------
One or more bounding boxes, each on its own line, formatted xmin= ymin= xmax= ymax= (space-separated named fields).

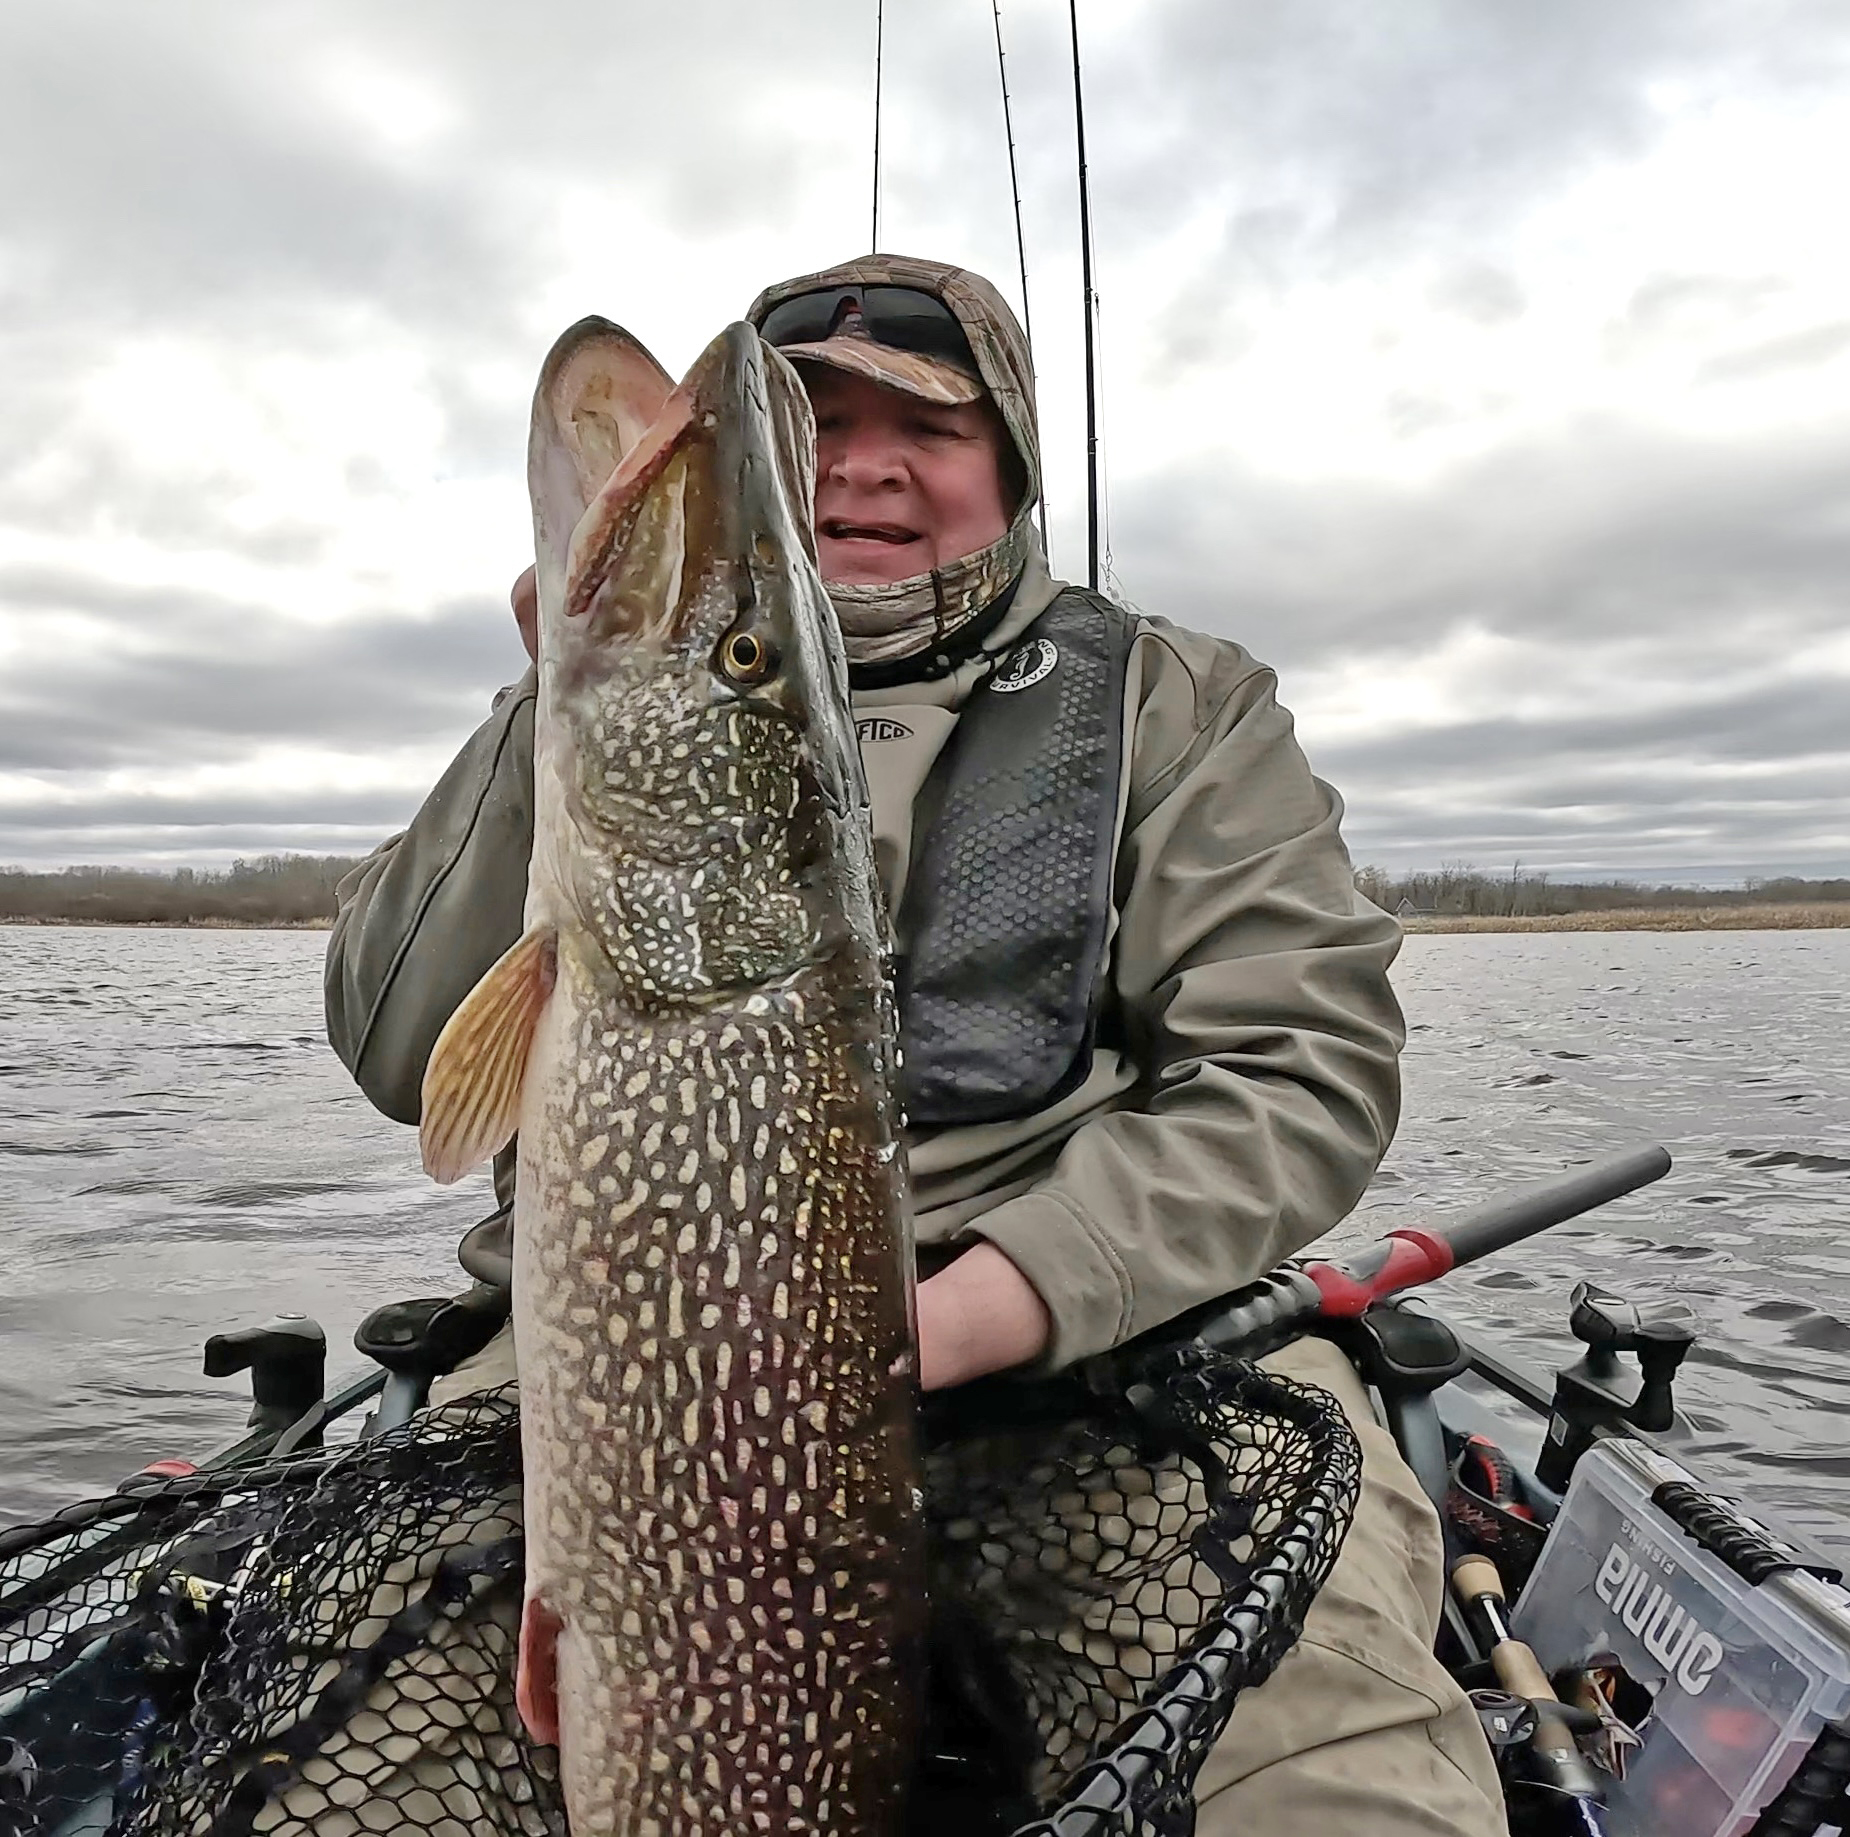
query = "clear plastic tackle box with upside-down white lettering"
xmin=1513 ymin=1439 xmax=1850 ymax=1837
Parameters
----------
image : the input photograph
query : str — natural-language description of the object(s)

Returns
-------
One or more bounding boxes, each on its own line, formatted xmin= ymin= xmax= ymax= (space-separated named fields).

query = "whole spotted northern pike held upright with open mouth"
xmin=424 ymin=318 xmax=925 ymax=1837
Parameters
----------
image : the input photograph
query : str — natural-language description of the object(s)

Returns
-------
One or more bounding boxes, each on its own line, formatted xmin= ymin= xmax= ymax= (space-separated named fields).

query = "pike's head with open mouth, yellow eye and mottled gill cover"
xmin=529 ymin=320 xmax=865 ymax=1005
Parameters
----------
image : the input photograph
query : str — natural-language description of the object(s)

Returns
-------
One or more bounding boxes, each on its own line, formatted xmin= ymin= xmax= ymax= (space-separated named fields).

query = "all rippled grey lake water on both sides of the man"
xmin=0 ymin=927 xmax=1850 ymax=1552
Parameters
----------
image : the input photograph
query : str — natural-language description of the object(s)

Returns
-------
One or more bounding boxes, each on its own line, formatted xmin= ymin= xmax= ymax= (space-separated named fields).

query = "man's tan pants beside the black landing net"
xmin=431 ymin=1332 xmax=1506 ymax=1837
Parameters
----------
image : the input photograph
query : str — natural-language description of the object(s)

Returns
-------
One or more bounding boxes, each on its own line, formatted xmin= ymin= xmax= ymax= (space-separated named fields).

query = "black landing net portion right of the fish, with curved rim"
xmin=927 ymin=1360 xmax=1362 ymax=1837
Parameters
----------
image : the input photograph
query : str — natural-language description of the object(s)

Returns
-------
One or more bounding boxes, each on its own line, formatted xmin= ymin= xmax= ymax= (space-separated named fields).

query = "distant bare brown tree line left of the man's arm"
xmin=0 ymin=855 xmax=353 ymax=925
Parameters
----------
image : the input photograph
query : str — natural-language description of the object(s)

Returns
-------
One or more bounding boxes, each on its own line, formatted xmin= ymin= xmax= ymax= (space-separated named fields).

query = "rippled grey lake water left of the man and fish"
xmin=0 ymin=927 xmax=490 ymax=1521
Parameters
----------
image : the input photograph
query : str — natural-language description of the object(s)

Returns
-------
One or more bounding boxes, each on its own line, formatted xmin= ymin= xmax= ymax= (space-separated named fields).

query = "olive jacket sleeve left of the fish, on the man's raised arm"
xmin=324 ymin=670 xmax=535 ymax=1123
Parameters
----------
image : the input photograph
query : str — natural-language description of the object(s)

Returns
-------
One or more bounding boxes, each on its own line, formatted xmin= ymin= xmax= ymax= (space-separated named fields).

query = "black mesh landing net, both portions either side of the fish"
xmin=0 ymin=1362 xmax=1360 ymax=1837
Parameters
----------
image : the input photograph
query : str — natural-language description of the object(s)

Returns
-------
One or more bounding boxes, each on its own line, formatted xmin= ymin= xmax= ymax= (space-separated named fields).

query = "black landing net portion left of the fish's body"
xmin=0 ymin=1395 xmax=543 ymax=1837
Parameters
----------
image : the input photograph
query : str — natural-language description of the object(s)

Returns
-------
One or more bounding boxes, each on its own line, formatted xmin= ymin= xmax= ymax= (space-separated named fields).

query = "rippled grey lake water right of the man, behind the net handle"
xmin=1345 ymin=931 xmax=1850 ymax=1558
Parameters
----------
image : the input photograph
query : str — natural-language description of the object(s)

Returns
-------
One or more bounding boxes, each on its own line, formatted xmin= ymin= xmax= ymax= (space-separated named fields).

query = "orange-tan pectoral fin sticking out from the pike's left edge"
xmin=418 ymin=925 xmax=559 ymax=1186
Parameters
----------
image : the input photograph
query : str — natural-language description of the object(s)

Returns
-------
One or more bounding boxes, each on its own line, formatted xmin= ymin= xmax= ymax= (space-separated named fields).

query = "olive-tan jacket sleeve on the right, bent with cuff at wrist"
xmin=964 ymin=633 xmax=1404 ymax=1369
